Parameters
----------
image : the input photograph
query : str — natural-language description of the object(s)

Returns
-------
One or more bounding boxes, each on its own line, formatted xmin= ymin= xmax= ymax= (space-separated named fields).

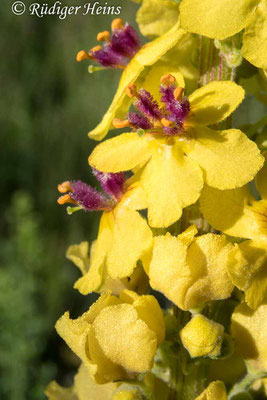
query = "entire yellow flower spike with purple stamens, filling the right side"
xmin=49 ymin=0 xmax=267 ymax=400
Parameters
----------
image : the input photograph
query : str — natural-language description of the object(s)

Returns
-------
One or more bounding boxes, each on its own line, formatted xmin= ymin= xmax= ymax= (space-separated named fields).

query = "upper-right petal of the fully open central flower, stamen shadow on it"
xmin=188 ymin=81 xmax=245 ymax=125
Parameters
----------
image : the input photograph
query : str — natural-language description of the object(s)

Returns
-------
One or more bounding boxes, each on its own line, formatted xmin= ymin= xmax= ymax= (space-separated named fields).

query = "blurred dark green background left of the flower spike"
xmin=0 ymin=0 xmax=140 ymax=400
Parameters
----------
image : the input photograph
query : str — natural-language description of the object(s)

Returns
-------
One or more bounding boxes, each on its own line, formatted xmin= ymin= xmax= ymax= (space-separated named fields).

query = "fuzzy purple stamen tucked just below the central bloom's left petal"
xmin=93 ymin=169 xmax=126 ymax=200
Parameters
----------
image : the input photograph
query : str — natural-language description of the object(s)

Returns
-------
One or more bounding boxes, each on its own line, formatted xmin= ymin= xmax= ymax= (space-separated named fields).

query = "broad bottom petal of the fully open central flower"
xmin=141 ymin=145 xmax=203 ymax=227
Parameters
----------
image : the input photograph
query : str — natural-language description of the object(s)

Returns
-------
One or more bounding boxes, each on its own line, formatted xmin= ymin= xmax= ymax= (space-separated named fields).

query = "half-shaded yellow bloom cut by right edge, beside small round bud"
xmin=231 ymin=300 xmax=267 ymax=371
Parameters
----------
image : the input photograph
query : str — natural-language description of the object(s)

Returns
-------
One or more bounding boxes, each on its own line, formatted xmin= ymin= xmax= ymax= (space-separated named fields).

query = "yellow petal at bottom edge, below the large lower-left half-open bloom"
xmin=74 ymin=364 xmax=118 ymax=400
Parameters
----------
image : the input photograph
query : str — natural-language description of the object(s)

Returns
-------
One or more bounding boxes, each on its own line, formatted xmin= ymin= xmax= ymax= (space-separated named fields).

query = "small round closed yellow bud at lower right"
xmin=180 ymin=314 xmax=224 ymax=358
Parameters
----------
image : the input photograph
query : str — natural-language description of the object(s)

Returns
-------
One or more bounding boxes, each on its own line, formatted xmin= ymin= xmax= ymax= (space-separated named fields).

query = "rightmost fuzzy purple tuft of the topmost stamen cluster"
xmin=110 ymin=24 xmax=140 ymax=58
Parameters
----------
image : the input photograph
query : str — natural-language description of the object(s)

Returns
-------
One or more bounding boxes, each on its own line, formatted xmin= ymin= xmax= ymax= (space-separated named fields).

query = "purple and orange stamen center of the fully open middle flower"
xmin=113 ymin=74 xmax=190 ymax=136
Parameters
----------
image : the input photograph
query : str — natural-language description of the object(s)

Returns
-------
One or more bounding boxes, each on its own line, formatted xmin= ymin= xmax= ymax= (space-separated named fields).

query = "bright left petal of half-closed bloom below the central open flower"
xmin=147 ymin=233 xmax=192 ymax=308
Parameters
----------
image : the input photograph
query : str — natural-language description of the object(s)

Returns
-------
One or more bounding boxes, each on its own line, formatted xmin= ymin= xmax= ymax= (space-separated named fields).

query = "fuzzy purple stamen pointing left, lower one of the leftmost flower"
xmin=69 ymin=181 xmax=110 ymax=211
